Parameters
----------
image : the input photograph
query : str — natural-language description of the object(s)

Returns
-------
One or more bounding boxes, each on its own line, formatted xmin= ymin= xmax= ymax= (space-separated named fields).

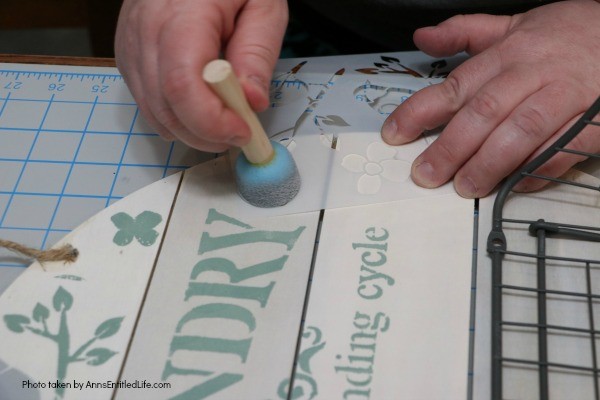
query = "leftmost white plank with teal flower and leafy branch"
xmin=0 ymin=174 xmax=181 ymax=400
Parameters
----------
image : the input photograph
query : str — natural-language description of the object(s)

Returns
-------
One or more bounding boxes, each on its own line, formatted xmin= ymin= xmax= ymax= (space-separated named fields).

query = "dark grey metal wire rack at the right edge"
xmin=487 ymin=97 xmax=600 ymax=400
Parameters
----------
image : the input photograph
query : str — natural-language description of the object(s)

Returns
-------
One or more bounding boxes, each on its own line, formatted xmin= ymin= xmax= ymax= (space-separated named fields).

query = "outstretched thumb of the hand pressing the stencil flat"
xmin=413 ymin=14 xmax=512 ymax=57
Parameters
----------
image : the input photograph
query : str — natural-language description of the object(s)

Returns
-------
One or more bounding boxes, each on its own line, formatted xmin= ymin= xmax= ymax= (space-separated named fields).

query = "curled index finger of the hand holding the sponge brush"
xmin=158 ymin=0 xmax=250 ymax=147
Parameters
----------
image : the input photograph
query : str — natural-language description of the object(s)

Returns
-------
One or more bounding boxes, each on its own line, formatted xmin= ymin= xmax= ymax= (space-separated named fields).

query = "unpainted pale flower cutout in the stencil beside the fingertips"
xmin=342 ymin=142 xmax=410 ymax=194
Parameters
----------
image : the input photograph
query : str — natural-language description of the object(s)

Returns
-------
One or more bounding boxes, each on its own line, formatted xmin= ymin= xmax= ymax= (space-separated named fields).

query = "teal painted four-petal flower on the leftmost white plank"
xmin=111 ymin=211 xmax=162 ymax=246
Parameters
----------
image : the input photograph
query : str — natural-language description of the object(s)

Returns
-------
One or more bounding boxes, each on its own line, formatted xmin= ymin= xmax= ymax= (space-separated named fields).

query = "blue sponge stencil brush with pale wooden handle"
xmin=203 ymin=60 xmax=300 ymax=207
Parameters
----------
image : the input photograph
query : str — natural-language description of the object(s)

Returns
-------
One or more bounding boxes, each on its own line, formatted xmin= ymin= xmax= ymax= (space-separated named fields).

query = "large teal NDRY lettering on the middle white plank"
xmin=162 ymin=209 xmax=305 ymax=400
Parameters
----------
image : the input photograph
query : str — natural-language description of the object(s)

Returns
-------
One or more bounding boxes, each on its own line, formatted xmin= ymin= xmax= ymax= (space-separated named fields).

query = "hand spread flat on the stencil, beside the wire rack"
xmin=382 ymin=0 xmax=600 ymax=198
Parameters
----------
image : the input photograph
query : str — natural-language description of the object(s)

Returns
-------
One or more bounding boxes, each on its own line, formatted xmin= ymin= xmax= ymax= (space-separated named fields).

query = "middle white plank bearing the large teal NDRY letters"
xmin=117 ymin=159 xmax=319 ymax=399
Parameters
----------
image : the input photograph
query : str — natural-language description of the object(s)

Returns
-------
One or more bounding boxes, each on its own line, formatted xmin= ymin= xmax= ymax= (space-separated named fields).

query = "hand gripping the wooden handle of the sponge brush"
xmin=115 ymin=0 xmax=288 ymax=152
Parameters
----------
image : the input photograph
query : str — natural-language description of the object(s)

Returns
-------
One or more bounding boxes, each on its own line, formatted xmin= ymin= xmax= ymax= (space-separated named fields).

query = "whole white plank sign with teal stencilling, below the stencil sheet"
xmin=0 ymin=151 xmax=473 ymax=399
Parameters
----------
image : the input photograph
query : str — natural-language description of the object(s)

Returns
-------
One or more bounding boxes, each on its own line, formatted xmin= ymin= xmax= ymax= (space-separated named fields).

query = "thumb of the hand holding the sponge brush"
xmin=226 ymin=0 xmax=288 ymax=111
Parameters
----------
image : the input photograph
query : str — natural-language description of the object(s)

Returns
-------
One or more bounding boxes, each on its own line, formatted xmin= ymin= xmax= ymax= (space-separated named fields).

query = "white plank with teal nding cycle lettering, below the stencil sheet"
xmin=292 ymin=194 xmax=473 ymax=399
